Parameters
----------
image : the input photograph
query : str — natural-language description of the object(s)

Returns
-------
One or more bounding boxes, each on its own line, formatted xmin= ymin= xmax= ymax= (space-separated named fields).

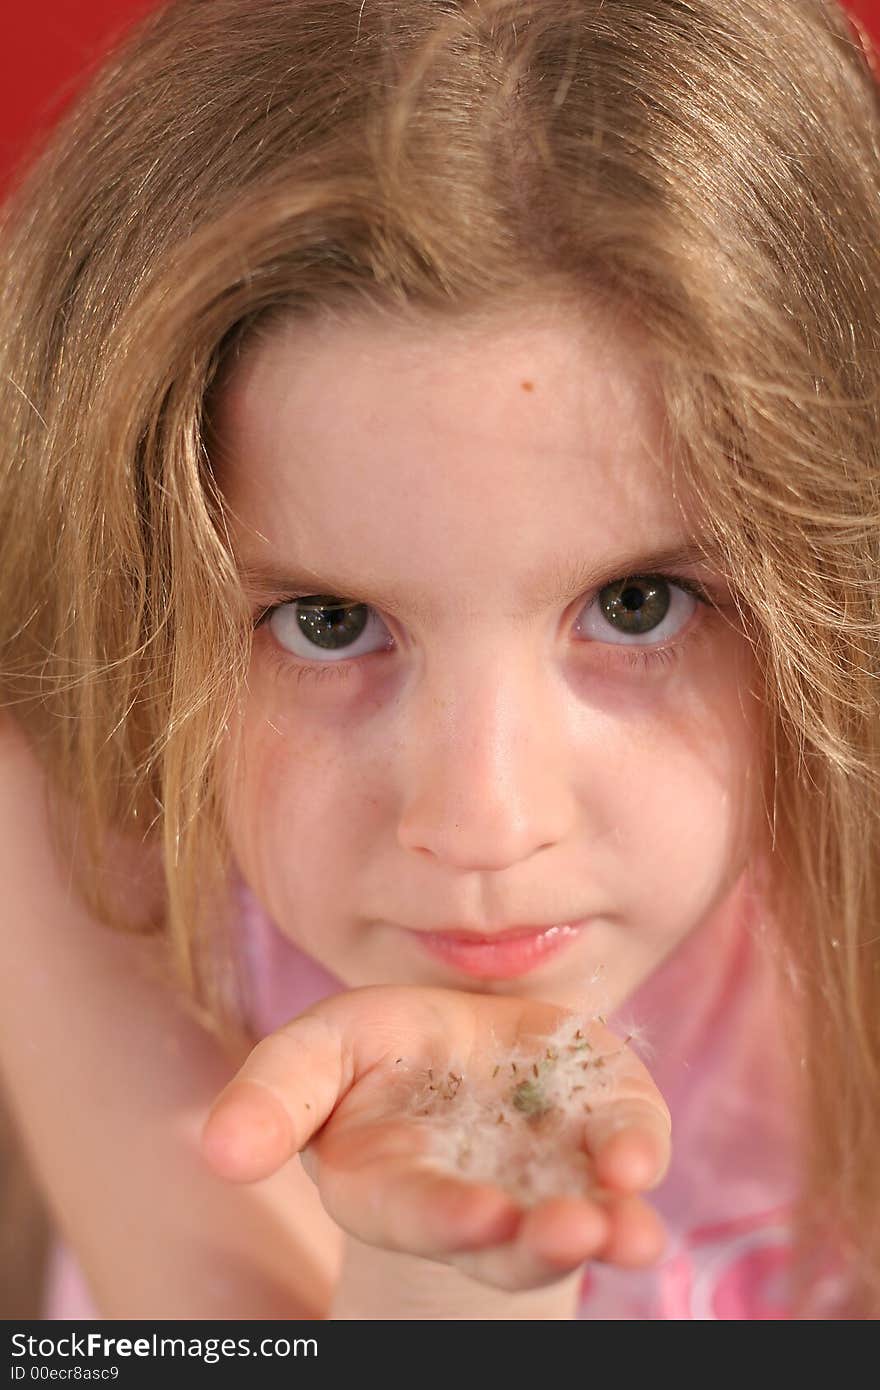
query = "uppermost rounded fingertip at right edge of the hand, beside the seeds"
xmin=584 ymin=1095 xmax=671 ymax=1193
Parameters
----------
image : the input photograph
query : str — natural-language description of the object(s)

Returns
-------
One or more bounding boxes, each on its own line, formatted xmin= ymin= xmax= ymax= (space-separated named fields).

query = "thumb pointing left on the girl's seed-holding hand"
xmin=200 ymin=1012 xmax=352 ymax=1183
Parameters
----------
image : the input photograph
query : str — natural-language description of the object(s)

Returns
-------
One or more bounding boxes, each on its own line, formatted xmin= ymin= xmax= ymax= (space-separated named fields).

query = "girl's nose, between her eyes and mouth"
xmin=398 ymin=653 xmax=574 ymax=872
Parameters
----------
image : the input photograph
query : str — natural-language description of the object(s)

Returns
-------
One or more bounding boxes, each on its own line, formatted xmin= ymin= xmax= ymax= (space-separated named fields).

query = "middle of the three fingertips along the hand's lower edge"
xmin=448 ymin=1197 xmax=612 ymax=1293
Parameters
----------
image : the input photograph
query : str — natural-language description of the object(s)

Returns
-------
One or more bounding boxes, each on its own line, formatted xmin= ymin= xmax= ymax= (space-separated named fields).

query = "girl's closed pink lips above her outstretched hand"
xmin=407 ymin=920 xmax=587 ymax=980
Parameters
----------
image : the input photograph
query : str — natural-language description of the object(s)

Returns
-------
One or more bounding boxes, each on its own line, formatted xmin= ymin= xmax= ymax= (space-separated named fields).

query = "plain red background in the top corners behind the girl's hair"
xmin=0 ymin=0 xmax=880 ymax=183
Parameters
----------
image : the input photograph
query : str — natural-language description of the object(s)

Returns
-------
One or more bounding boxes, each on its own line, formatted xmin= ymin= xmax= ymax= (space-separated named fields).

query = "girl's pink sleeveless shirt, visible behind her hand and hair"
xmin=44 ymin=876 xmax=842 ymax=1321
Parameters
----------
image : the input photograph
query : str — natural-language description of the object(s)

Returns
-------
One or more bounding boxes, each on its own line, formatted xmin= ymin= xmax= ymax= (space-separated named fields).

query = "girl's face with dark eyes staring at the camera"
xmin=217 ymin=309 xmax=760 ymax=1008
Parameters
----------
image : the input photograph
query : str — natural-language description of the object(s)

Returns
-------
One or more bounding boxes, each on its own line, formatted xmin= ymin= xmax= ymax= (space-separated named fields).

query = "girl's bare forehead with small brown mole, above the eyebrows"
xmin=215 ymin=307 xmax=684 ymax=611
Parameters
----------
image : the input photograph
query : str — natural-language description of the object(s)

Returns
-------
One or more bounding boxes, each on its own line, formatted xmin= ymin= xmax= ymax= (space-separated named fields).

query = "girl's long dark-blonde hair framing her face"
xmin=0 ymin=0 xmax=880 ymax=1316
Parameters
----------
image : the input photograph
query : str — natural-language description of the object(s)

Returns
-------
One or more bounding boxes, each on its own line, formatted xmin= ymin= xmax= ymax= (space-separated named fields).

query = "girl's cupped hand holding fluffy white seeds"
xmin=202 ymin=986 xmax=671 ymax=1291
